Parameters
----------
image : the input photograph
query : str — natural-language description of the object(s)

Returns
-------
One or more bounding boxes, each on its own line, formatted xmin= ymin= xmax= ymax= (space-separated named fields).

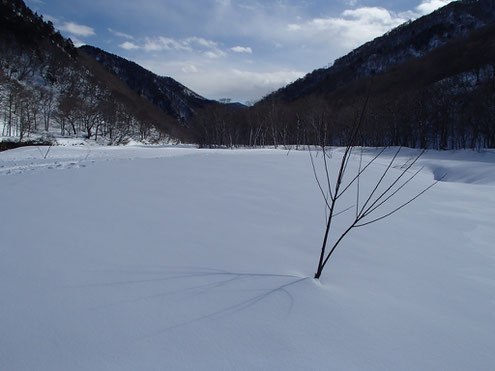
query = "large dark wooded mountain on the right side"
xmin=224 ymin=0 xmax=495 ymax=149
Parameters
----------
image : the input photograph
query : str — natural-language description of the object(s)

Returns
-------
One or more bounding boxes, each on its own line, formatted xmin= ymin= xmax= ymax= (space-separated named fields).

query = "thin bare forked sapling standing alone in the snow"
xmin=309 ymin=98 xmax=441 ymax=279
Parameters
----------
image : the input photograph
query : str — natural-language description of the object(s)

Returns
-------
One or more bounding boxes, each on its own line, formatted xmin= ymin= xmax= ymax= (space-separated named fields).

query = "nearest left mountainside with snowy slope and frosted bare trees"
xmin=0 ymin=0 xmax=192 ymax=144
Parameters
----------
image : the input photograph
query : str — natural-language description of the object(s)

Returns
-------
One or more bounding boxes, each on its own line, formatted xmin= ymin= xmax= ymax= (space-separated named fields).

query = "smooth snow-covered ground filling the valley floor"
xmin=0 ymin=146 xmax=495 ymax=370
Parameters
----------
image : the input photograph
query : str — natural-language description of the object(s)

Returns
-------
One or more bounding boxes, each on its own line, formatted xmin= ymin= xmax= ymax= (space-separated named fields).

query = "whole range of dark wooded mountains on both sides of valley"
xmin=0 ymin=0 xmax=495 ymax=149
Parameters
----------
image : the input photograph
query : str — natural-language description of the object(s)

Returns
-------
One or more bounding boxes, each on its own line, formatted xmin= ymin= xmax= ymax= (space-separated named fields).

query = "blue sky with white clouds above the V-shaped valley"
xmin=26 ymin=0 xmax=450 ymax=102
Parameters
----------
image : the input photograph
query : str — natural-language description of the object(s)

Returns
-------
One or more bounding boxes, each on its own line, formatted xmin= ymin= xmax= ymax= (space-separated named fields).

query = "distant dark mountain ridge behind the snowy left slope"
xmin=79 ymin=45 xmax=212 ymax=123
